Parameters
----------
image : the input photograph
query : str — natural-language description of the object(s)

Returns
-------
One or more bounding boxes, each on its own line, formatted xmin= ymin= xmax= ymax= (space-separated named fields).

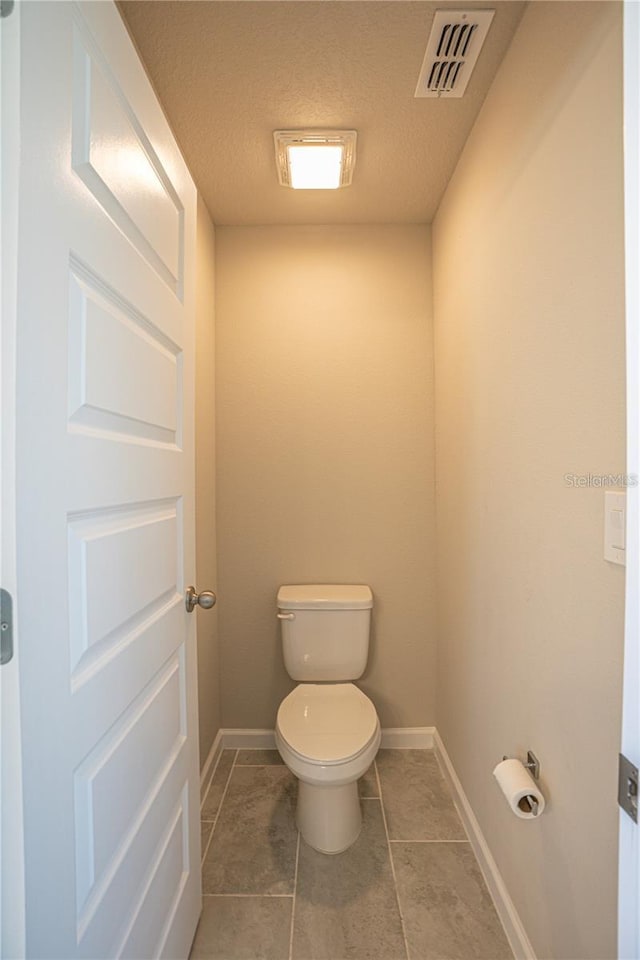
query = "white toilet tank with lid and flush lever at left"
xmin=278 ymin=583 xmax=373 ymax=682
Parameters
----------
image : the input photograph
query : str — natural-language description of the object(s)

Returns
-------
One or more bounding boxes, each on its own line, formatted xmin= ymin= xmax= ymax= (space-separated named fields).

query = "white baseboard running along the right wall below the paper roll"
xmin=433 ymin=730 xmax=536 ymax=960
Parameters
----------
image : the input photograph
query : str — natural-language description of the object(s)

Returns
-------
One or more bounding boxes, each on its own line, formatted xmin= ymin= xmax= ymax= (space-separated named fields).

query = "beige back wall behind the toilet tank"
xmin=216 ymin=226 xmax=435 ymax=728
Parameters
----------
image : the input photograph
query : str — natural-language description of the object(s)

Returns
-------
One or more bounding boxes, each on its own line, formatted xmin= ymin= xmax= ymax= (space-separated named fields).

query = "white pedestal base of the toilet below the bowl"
xmin=296 ymin=780 xmax=362 ymax=854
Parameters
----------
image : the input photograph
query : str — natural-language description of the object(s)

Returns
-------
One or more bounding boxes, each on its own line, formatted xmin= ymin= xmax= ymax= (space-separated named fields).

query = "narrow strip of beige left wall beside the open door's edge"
xmin=196 ymin=197 xmax=220 ymax=767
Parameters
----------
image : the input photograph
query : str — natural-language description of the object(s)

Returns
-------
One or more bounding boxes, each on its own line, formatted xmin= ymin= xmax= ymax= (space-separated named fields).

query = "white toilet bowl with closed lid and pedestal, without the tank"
xmin=276 ymin=683 xmax=381 ymax=854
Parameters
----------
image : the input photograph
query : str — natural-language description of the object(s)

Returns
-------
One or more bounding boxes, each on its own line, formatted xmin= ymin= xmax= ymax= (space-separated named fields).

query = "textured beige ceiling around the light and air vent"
xmin=120 ymin=0 xmax=524 ymax=224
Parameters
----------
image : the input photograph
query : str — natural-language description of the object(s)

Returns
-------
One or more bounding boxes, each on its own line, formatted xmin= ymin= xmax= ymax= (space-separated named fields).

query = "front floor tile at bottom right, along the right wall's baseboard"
xmin=391 ymin=843 xmax=513 ymax=960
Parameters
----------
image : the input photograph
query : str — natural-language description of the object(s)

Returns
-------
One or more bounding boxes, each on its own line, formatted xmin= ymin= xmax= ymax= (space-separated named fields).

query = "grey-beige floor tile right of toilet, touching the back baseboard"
xmin=376 ymin=750 xmax=467 ymax=840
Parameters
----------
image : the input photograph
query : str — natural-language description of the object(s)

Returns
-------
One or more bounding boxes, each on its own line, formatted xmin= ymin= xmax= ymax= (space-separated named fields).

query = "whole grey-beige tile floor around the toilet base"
xmin=191 ymin=750 xmax=512 ymax=960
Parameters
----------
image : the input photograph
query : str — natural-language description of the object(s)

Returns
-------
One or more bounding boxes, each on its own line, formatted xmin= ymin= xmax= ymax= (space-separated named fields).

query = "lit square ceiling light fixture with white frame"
xmin=273 ymin=130 xmax=357 ymax=190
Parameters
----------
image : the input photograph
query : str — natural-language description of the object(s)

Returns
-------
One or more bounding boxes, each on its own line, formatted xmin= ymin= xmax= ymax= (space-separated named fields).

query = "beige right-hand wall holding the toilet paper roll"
xmin=433 ymin=2 xmax=625 ymax=960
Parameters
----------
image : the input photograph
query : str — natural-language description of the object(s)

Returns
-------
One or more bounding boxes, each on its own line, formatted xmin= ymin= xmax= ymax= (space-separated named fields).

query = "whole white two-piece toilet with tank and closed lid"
xmin=276 ymin=584 xmax=381 ymax=854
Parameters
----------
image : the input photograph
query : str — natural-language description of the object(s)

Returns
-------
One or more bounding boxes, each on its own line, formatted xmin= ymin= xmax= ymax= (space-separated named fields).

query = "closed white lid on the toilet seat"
xmin=277 ymin=683 xmax=378 ymax=763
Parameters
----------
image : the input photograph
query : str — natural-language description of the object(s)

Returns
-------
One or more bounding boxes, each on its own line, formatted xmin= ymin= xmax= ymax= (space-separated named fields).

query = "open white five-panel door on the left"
xmin=17 ymin=2 xmax=200 ymax=960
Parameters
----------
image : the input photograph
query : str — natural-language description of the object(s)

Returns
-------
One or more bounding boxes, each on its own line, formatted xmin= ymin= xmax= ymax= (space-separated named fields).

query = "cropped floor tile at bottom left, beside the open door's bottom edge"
xmin=190 ymin=897 xmax=293 ymax=960
